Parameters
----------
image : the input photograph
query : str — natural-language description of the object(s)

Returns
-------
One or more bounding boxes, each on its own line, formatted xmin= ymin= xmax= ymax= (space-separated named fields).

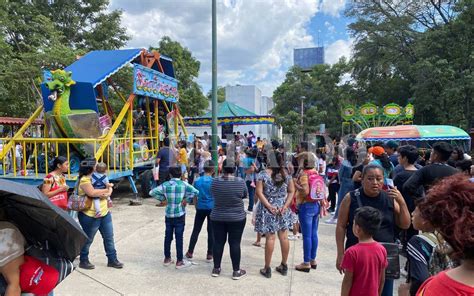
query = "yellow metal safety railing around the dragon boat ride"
xmin=0 ymin=136 xmax=157 ymax=179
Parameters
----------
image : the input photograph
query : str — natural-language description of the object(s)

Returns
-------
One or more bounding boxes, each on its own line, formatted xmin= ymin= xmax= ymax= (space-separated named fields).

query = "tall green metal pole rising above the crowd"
xmin=211 ymin=0 xmax=218 ymax=172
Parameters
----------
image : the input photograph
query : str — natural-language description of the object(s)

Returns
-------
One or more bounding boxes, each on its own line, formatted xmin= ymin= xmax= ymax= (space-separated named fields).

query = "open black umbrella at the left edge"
xmin=0 ymin=179 xmax=87 ymax=261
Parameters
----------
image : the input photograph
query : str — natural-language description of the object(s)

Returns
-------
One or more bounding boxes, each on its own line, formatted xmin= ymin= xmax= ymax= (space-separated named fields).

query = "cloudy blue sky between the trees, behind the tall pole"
xmin=109 ymin=0 xmax=352 ymax=96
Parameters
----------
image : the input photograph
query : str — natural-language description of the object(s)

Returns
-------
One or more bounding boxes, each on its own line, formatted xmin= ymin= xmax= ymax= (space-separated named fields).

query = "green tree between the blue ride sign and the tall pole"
xmin=150 ymin=36 xmax=209 ymax=116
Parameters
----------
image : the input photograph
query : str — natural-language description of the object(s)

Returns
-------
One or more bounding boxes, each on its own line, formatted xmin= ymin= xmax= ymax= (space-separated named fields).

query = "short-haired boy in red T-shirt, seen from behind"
xmin=341 ymin=207 xmax=388 ymax=296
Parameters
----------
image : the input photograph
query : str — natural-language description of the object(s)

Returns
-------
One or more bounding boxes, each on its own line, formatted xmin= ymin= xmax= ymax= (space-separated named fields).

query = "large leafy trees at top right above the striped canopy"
xmin=346 ymin=0 xmax=474 ymax=129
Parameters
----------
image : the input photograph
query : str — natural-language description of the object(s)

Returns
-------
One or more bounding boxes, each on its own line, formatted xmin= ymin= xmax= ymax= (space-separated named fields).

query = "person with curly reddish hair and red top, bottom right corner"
xmin=416 ymin=174 xmax=474 ymax=296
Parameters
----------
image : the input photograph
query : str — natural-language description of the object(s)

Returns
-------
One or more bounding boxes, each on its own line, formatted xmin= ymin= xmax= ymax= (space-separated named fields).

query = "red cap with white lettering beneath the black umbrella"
xmin=20 ymin=255 xmax=59 ymax=295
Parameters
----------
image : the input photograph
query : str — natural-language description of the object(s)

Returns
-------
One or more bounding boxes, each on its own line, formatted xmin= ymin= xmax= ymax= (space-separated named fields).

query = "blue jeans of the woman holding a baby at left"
xmin=78 ymin=212 xmax=117 ymax=262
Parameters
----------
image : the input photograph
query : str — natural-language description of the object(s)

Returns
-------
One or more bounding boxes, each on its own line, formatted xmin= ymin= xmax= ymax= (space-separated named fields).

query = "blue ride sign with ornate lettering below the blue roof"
xmin=133 ymin=64 xmax=178 ymax=103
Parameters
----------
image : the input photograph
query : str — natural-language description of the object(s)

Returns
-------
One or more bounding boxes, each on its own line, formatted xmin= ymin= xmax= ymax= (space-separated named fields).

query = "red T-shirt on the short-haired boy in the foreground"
xmin=341 ymin=242 xmax=388 ymax=296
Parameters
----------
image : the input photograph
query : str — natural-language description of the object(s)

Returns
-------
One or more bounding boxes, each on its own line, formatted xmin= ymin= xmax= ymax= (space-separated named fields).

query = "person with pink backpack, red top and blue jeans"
xmin=295 ymin=152 xmax=326 ymax=272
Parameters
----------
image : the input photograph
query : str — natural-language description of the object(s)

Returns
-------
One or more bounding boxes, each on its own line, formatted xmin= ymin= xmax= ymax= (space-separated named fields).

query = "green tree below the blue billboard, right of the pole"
xmin=272 ymin=59 xmax=354 ymax=137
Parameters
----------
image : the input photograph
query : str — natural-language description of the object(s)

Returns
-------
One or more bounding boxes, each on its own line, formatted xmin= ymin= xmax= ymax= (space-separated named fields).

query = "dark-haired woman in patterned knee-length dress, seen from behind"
xmin=255 ymin=150 xmax=294 ymax=278
